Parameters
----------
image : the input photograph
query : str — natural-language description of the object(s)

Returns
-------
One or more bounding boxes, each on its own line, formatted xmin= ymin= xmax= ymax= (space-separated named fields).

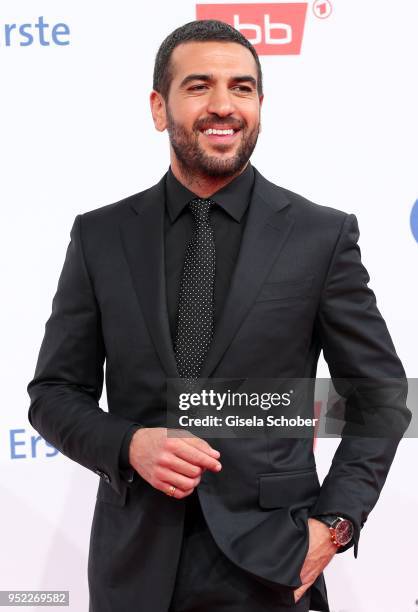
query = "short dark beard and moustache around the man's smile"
xmin=167 ymin=106 xmax=259 ymax=178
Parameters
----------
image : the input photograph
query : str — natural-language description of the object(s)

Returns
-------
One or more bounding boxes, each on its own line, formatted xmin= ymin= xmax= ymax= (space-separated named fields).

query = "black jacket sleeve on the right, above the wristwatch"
xmin=310 ymin=215 xmax=411 ymax=557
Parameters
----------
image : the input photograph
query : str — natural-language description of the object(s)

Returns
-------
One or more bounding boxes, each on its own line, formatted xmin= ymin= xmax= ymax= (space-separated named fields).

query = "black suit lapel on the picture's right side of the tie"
xmin=201 ymin=168 xmax=293 ymax=378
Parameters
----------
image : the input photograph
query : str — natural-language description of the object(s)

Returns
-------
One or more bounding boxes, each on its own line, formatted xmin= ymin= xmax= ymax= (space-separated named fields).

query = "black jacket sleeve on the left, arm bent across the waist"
xmin=27 ymin=215 xmax=143 ymax=494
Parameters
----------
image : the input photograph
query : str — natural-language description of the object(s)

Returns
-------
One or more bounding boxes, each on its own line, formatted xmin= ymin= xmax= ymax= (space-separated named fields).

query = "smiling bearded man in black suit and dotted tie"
xmin=28 ymin=20 xmax=409 ymax=612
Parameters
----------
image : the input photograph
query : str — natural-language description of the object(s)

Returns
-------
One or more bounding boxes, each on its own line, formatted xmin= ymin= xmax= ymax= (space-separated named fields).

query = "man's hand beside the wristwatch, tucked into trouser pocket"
xmin=294 ymin=518 xmax=337 ymax=602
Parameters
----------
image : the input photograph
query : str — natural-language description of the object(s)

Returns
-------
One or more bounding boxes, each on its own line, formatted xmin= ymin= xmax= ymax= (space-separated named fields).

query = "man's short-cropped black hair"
xmin=153 ymin=19 xmax=263 ymax=101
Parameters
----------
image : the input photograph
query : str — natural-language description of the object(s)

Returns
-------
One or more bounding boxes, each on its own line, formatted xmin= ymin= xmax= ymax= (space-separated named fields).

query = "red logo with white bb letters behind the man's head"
xmin=196 ymin=2 xmax=308 ymax=55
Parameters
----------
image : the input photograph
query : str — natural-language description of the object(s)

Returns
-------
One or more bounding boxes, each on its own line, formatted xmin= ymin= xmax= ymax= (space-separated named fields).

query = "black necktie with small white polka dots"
xmin=174 ymin=198 xmax=216 ymax=380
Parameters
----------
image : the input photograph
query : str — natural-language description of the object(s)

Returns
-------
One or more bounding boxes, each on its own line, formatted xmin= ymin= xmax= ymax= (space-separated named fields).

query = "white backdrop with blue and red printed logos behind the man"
xmin=0 ymin=0 xmax=418 ymax=612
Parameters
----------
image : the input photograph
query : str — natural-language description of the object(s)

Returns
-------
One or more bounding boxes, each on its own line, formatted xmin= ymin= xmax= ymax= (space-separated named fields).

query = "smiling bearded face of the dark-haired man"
xmin=151 ymin=41 xmax=262 ymax=177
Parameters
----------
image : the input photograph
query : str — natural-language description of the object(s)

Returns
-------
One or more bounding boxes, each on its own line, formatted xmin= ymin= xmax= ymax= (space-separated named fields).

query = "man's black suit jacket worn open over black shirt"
xmin=28 ymin=165 xmax=410 ymax=612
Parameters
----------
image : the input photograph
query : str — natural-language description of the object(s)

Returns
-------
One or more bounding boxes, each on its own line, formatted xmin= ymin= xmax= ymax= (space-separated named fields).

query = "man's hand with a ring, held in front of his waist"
xmin=129 ymin=427 xmax=222 ymax=499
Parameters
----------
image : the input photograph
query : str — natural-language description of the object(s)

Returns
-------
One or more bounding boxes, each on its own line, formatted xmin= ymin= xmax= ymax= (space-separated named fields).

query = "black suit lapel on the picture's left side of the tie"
xmin=121 ymin=175 xmax=178 ymax=378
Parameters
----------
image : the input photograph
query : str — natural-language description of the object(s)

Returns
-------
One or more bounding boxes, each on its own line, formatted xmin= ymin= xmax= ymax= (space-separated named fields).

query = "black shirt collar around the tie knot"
xmin=165 ymin=162 xmax=254 ymax=223
